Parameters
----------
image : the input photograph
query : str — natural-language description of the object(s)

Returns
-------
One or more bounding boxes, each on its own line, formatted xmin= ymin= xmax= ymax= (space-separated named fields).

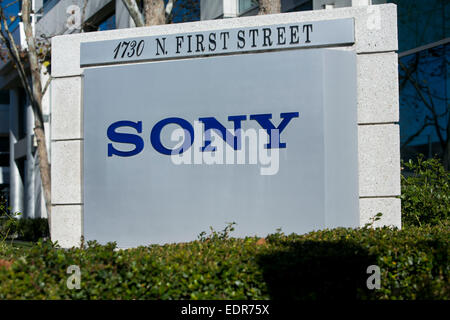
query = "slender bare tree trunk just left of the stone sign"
xmin=22 ymin=0 xmax=52 ymax=226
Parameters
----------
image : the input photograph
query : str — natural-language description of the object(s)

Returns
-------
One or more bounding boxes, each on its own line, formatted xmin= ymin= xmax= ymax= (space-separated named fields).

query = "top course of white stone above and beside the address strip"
xmin=52 ymin=4 xmax=398 ymax=77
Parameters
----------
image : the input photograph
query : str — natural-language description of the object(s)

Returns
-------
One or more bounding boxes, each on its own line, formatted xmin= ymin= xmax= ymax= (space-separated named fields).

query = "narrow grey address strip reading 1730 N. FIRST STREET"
xmin=80 ymin=18 xmax=355 ymax=67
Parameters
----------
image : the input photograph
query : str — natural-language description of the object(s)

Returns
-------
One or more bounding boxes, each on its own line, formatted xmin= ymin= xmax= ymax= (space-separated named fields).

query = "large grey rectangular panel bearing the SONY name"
xmin=83 ymin=48 xmax=359 ymax=247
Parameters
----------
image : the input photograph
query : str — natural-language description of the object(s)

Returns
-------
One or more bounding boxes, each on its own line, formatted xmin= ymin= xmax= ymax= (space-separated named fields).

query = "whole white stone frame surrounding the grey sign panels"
xmin=51 ymin=4 xmax=401 ymax=247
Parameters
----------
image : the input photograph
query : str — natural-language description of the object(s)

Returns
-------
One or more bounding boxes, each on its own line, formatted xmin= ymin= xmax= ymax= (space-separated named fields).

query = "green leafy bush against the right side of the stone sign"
xmin=401 ymin=156 xmax=450 ymax=226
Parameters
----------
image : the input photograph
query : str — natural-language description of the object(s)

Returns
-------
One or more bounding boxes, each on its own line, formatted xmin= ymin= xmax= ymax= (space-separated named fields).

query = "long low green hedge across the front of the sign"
xmin=0 ymin=223 xmax=450 ymax=299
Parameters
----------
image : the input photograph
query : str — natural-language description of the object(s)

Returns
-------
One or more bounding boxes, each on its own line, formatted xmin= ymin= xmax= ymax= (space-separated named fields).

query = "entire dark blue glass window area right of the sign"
xmin=388 ymin=0 xmax=450 ymax=160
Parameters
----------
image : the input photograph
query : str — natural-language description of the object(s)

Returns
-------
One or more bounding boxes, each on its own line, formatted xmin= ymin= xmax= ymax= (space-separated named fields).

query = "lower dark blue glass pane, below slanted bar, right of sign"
xmin=399 ymin=43 xmax=450 ymax=160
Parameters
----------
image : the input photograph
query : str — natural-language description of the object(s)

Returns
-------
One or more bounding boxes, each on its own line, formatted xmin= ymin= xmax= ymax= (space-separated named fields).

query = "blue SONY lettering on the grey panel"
xmin=107 ymin=112 xmax=299 ymax=157
